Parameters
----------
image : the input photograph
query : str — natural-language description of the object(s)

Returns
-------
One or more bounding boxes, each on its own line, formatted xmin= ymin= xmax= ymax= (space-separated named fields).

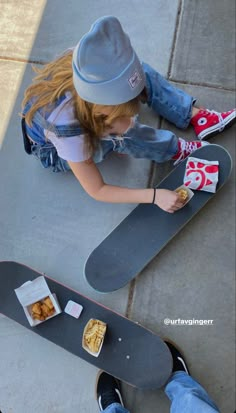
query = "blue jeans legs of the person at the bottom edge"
xmin=104 ymin=371 xmax=219 ymax=413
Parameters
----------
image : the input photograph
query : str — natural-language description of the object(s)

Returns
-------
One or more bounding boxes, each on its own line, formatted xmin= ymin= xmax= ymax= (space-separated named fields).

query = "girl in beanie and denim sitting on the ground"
xmin=22 ymin=16 xmax=236 ymax=213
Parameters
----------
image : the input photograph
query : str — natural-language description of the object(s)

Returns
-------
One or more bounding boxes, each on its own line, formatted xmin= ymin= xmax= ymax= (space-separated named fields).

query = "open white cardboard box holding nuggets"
xmin=15 ymin=276 xmax=61 ymax=327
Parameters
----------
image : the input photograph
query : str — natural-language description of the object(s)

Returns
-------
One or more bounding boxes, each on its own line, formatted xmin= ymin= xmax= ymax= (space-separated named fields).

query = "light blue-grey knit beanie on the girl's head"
xmin=72 ymin=16 xmax=145 ymax=105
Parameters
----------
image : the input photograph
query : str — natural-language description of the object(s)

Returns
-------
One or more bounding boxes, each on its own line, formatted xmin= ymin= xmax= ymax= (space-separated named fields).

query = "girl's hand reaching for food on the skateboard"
xmin=155 ymin=189 xmax=185 ymax=214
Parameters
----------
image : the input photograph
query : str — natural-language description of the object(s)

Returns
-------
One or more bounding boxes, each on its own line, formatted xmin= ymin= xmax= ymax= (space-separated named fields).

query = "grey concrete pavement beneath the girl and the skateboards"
xmin=0 ymin=0 xmax=235 ymax=413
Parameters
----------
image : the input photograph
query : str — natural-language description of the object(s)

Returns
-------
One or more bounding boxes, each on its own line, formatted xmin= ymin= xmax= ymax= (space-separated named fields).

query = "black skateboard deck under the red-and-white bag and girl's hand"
xmin=84 ymin=144 xmax=232 ymax=293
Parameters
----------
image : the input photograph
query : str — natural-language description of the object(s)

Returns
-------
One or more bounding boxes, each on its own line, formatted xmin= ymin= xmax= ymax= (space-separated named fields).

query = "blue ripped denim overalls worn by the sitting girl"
xmin=23 ymin=63 xmax=195 ymax=172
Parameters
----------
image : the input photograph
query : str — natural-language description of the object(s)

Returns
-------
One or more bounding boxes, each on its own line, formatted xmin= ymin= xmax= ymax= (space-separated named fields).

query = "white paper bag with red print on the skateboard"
xmin=184 ymin=157 xmax=219 ymax=192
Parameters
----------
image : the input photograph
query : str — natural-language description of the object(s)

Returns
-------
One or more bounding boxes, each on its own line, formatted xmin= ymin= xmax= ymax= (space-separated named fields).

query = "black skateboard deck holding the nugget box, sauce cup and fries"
xmin=0 ymin=261 xmax=172 ymax=389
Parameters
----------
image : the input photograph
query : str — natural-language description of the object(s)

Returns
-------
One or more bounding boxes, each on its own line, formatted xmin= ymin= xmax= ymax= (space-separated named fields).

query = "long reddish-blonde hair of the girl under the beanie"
xmin=22 ymin=50 xmax=140 ymax=153
